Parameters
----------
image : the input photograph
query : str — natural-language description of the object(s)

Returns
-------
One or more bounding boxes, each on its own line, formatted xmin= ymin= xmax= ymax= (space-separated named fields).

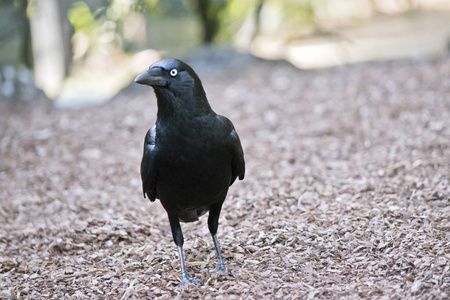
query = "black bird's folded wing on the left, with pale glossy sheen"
xmin=141 ymin=125 xmax=156 ymax=202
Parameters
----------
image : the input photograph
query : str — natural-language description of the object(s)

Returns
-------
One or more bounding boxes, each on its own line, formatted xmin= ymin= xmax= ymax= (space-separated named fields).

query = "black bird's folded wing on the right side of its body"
xmin=216 ymin=115 xmax=245 ymax=185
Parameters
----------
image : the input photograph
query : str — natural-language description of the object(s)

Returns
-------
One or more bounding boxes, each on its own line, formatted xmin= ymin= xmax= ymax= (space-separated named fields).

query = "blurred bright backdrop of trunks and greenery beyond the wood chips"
xmin=0 ymin=0 xmax=450 ymax=107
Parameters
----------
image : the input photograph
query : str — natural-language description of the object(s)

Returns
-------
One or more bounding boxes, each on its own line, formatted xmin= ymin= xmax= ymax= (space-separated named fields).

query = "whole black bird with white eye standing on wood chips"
xmin=135 ymin=59 xmax=245 ymax=285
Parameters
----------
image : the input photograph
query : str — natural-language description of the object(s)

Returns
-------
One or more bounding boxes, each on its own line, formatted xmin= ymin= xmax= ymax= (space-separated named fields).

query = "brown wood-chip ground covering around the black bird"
xmin=0 ymin=57 xmax=450 ymax=299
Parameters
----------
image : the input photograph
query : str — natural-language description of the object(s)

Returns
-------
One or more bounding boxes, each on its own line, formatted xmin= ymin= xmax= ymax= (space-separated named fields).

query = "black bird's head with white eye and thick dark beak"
xmin=134 ymin=58 xmax=205 ymax=98
